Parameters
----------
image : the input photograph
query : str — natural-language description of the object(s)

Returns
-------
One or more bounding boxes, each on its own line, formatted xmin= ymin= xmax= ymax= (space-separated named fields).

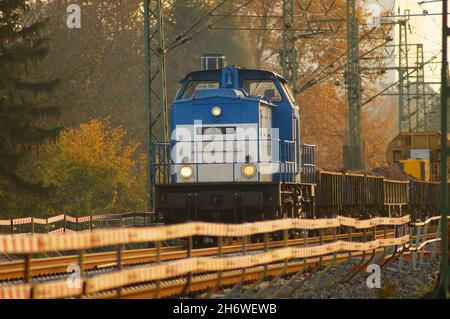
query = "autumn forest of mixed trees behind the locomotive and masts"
xmin=0 ymin=0 xmax=396 ymax=218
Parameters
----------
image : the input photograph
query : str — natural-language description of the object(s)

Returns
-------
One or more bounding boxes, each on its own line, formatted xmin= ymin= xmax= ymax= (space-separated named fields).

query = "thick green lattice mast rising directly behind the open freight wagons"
xmin=344 ymin=0 xmax=364 ymax=170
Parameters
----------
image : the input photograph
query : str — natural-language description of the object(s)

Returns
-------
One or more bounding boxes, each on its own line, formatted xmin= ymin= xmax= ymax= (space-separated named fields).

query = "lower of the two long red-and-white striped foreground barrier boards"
xmin=0 ymin=235 xmax=409 ymax=299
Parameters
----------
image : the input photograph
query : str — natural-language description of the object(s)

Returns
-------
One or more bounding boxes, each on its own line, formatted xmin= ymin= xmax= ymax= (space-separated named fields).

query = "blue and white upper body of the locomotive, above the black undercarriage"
xmin=170 ymin=67 xmax=300 ymax=183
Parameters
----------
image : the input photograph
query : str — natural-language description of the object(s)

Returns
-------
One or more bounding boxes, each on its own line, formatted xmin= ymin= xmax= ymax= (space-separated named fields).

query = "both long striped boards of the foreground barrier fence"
xmin=0 ymin=216 xmax=446 ymax=299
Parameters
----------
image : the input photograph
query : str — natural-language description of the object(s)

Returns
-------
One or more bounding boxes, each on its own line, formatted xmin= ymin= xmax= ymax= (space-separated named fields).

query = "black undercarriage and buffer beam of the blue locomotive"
xmin=155 ymin=182 xmax=314 ymax=224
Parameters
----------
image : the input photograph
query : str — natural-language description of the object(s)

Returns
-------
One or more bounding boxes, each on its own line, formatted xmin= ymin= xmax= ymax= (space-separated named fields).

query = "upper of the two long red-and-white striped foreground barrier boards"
xmin=0 ymin=216 xmax=410 ymax=254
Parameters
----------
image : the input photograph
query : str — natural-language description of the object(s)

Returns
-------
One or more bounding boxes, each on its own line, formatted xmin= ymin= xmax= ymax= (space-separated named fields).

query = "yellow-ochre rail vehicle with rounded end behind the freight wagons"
xmin=386 ymin=132 xmax=450 ymax=182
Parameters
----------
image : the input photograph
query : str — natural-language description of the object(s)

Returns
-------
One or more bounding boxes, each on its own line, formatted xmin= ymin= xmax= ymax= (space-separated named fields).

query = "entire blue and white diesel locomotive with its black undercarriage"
xmin=153 ymin=56 xmax=314 ymax=224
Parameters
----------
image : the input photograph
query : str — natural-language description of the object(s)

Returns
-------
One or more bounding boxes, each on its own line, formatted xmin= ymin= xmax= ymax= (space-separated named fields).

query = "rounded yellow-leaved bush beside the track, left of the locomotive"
xmin=39 ymin=120 xmax=145 ymax=215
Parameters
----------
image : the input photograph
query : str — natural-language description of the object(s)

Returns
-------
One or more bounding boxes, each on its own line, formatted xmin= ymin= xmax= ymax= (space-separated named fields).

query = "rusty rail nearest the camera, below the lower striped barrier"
xmin=88 ymin=239 xmax=436 ymax=299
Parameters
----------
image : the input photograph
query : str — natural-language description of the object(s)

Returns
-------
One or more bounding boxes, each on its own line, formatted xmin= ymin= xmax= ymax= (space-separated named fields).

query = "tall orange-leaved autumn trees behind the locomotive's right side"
xmin=237 ymin=0 xmax=393 ymax=168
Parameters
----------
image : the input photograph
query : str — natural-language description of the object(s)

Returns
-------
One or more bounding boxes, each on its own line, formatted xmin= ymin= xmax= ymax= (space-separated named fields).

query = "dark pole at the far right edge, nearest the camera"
xmin=434 ymin=1 xmax=450 ymax=298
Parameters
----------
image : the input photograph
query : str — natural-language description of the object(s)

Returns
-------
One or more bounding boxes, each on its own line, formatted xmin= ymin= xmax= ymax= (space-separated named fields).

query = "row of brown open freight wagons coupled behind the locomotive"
xmin=312 ymin=171 xmax=440 ymax=221
